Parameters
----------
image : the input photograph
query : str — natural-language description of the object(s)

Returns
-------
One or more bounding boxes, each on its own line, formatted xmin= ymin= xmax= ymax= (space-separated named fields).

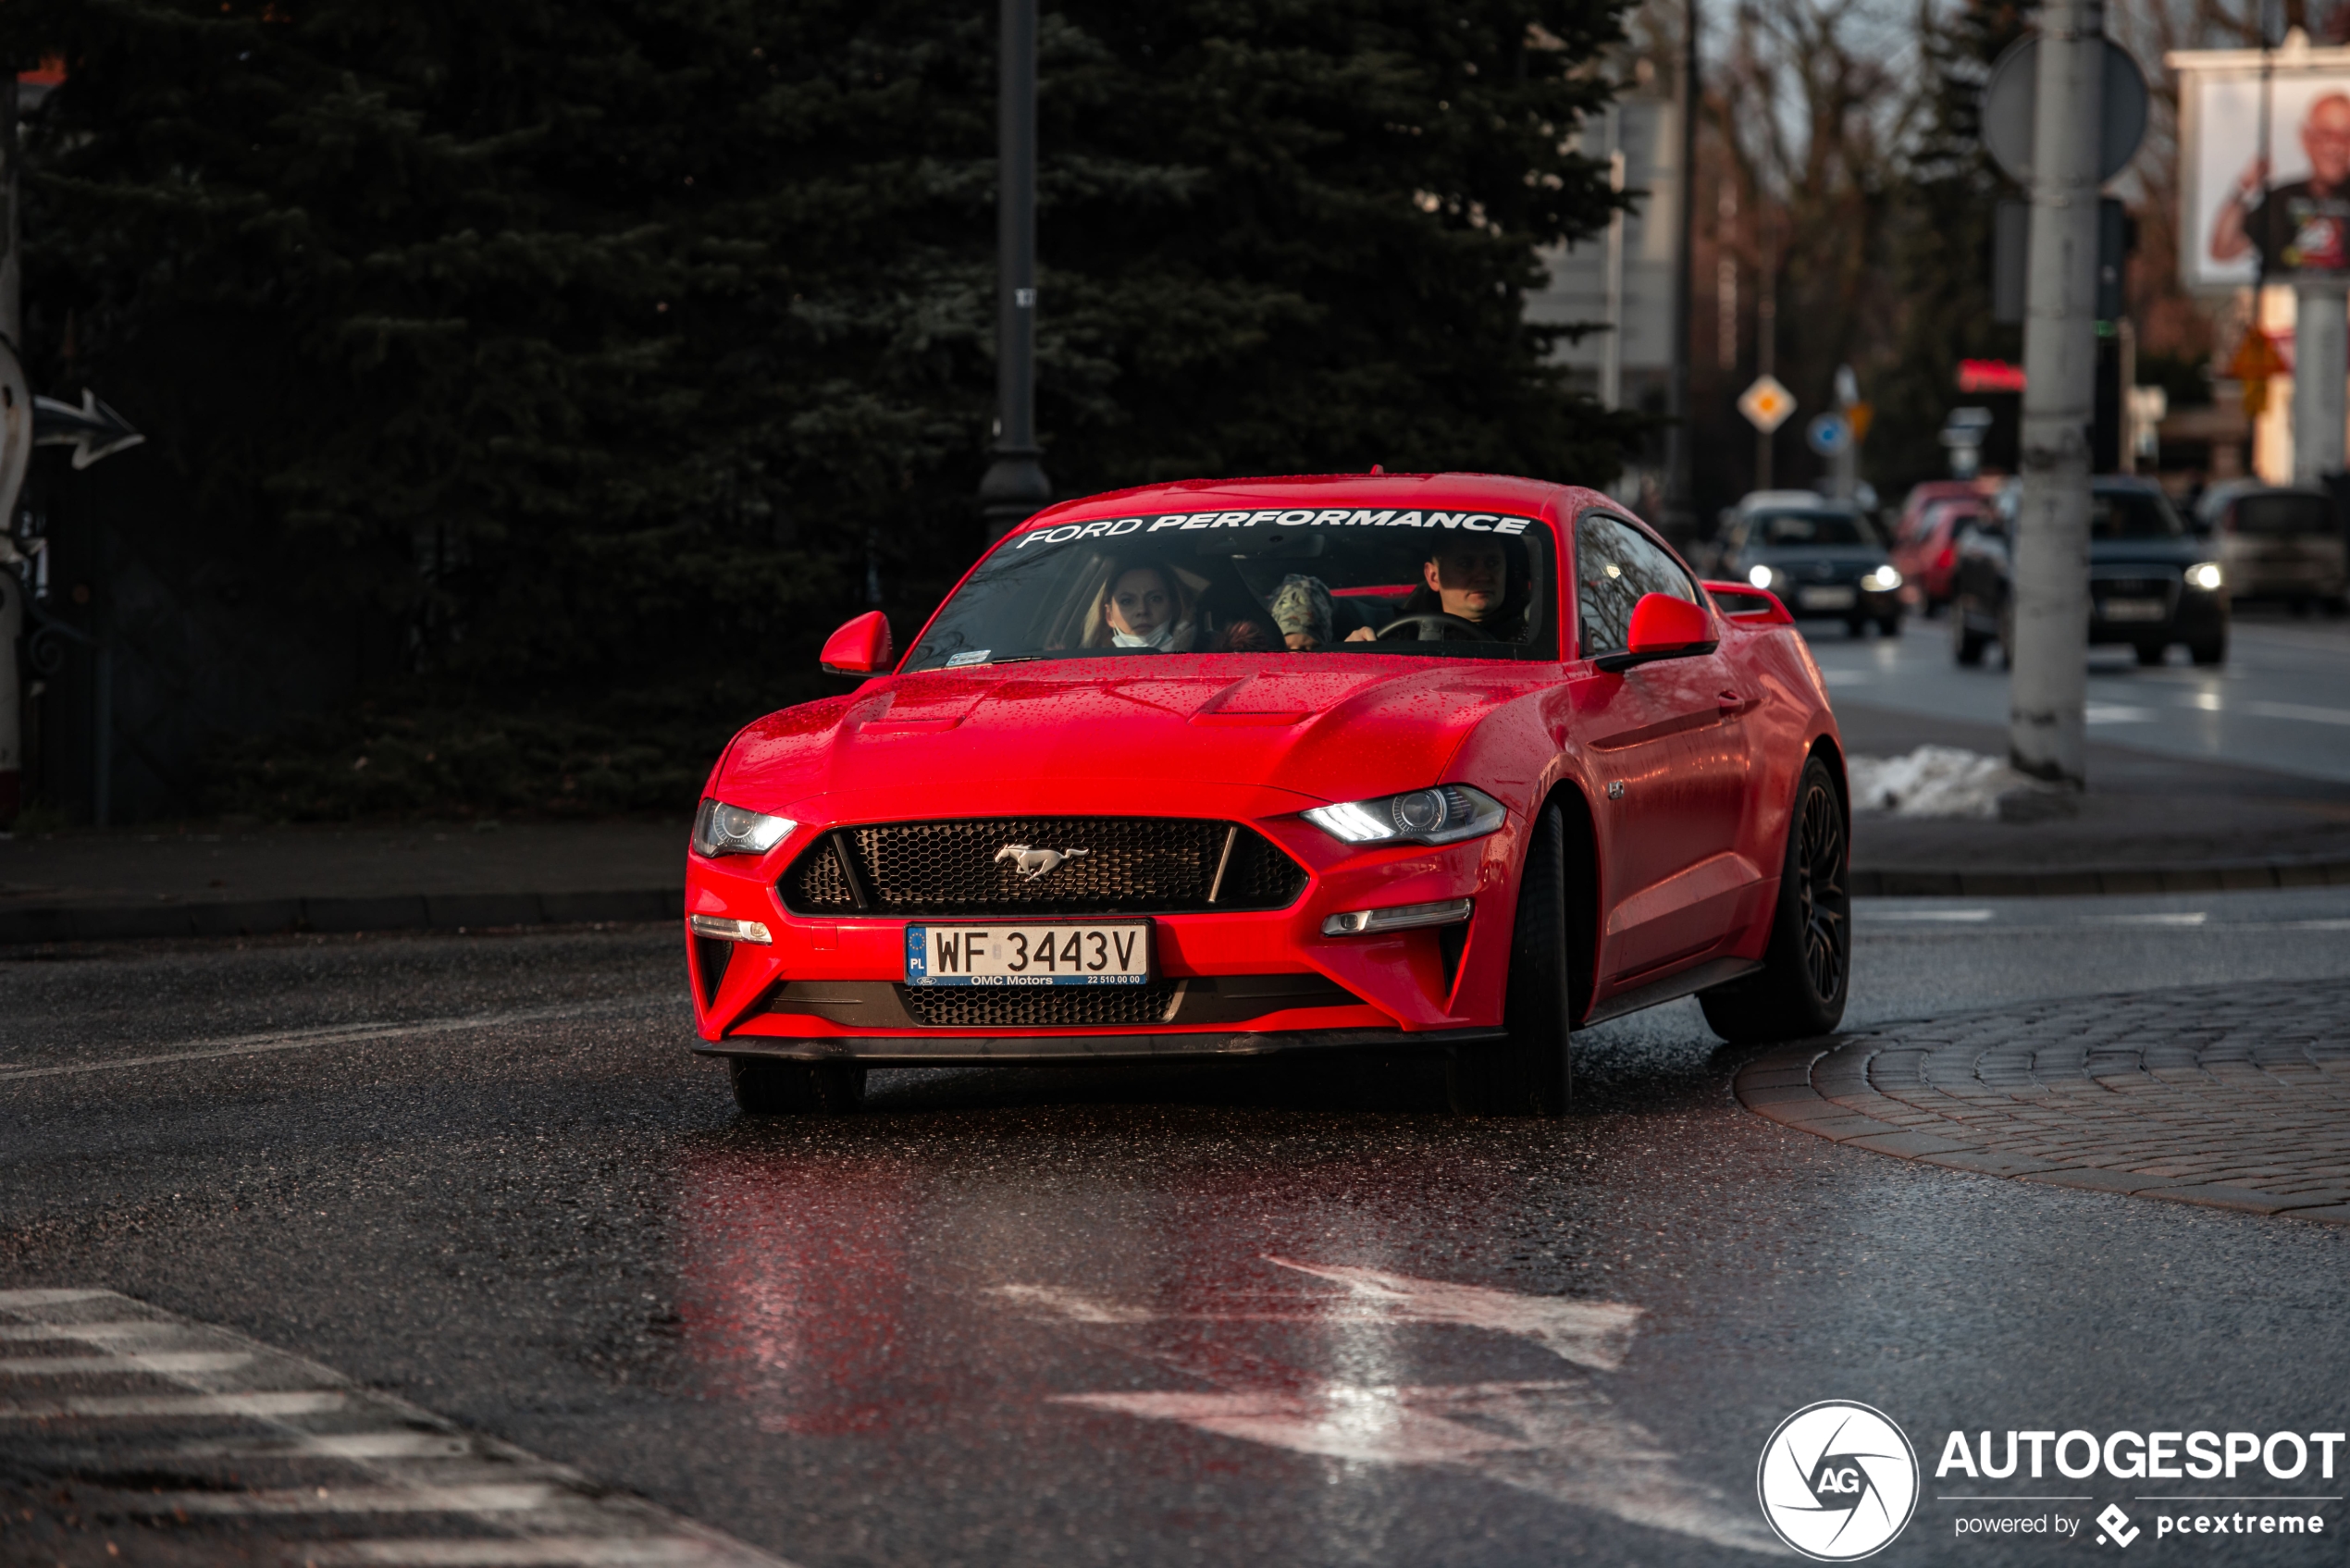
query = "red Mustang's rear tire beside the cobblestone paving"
xmin=1697 ymin=757 xmax=1852 ymax=1043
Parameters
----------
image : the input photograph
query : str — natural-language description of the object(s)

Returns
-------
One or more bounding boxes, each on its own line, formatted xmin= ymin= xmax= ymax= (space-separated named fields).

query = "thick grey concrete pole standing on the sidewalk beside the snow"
xmin=2007 ymin=0 xmax=2106 ymax=790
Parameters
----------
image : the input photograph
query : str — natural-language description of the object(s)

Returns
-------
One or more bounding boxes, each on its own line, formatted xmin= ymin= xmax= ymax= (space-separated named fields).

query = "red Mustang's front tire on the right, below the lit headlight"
xmin=1445 ymin=807 xmax=1575 ymax=1117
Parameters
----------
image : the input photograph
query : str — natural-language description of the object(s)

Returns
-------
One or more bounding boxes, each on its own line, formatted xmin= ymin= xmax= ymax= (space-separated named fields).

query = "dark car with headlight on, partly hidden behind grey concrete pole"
xmin=1950 ymin=477 xmax=2228 ymax=665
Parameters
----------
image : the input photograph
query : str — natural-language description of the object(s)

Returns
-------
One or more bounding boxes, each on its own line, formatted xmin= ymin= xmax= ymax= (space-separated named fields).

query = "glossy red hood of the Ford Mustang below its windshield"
xmin=719 ymin=653 xmax=1540 ymax=821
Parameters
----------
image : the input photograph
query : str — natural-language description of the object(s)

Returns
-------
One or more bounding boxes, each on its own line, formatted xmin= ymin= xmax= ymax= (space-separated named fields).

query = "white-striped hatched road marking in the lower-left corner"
xmin=0 ymin=1288 xmax=789 ymax=1568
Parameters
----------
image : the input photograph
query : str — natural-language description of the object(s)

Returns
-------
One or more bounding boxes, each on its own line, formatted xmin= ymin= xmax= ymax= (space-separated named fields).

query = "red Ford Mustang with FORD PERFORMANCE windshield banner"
xmin=686 ymin=475 xmax=1852 ymax=1115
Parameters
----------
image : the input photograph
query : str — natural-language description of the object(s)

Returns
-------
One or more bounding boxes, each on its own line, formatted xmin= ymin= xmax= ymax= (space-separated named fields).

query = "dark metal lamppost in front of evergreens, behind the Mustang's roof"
xmin=980 ymin=0 xmax=1053 ymax=543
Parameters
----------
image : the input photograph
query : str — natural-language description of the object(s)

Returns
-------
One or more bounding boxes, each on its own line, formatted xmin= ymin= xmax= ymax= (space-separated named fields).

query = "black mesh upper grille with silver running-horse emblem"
xmin=780 ymin=816 xmax=1306 ymax=921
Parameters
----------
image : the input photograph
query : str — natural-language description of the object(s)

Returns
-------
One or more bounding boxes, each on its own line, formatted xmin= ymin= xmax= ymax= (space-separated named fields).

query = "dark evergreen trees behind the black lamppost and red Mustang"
xmin=0 ymin=0 xmax=1636 ymax=813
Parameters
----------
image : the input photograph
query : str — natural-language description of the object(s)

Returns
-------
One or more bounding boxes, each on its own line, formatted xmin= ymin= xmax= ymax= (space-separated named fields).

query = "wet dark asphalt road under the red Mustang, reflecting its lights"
xmin=0 ymin=889 xmax=2350 ymax=1568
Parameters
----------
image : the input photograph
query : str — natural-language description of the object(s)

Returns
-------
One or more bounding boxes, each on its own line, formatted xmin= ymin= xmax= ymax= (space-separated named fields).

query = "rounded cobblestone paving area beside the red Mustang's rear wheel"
xmin=1737 ymin=981 xmax=2350 ymax=1225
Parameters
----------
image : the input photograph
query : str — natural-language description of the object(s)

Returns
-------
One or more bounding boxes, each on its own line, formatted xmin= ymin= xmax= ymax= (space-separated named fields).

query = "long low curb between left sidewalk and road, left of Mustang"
xmin=0 ymin=889 xmax=686 ymax=945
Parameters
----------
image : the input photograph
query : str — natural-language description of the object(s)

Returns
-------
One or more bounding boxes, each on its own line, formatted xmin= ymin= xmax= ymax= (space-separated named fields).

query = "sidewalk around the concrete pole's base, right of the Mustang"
xmin=1836 ymin=700 xmax=2350 ymax=898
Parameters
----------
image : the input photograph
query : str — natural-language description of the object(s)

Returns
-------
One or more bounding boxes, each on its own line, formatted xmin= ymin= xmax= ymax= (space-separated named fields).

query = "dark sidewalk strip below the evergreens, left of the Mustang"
xmin=0 ymin=818 xmax=688 ymax=943
